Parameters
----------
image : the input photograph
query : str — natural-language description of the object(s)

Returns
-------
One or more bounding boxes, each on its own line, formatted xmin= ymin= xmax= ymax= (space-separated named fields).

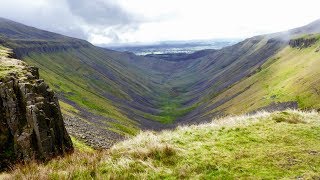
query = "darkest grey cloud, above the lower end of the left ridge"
xmin=66 ymin=0 xmax=147 ymax=43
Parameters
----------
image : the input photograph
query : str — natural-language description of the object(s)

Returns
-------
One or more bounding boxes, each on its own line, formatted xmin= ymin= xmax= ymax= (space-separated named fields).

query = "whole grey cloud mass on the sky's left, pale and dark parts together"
xmin=0 ymin=0 xmax=147 ymax=43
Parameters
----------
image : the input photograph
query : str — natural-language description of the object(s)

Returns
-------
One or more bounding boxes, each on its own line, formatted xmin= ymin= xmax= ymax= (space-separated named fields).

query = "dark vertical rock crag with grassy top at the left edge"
xmin=0 ymin=58 xmax=73 ymax=169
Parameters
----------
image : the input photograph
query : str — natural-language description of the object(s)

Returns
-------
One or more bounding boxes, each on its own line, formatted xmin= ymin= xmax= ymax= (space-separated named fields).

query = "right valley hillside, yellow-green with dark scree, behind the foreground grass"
xmin=172 ymin=20 xmax=320 ymax=123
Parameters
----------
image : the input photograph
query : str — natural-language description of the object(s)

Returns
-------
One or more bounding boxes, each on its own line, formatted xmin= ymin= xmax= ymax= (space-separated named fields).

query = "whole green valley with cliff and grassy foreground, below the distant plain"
xmin=0 ymin=15 xmax=320 ymax=179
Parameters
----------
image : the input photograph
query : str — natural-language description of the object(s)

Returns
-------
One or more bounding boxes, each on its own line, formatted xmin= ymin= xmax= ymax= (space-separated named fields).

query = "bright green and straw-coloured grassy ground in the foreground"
xmin=0 ymin=111 xmax=320 ymax=179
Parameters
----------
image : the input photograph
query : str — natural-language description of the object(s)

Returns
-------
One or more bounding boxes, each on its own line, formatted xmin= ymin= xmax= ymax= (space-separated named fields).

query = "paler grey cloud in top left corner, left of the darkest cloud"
xmin=0 ymin=0 xmax=88 ymax=39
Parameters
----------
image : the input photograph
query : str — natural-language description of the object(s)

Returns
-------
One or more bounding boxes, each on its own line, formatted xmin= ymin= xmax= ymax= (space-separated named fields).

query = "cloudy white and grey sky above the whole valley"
xmin=0 ymin=0 xmax=320 ymax=45
